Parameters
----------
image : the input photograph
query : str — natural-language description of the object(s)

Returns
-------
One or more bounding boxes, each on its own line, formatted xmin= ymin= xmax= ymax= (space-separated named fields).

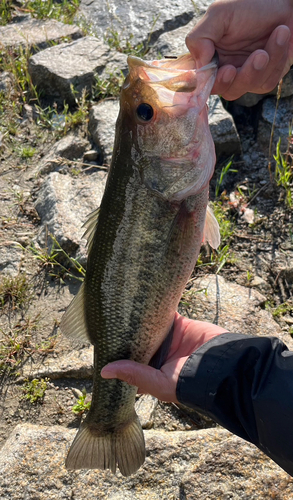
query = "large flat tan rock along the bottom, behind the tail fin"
xmin=0 ymin=424 xmax=293 ymax=500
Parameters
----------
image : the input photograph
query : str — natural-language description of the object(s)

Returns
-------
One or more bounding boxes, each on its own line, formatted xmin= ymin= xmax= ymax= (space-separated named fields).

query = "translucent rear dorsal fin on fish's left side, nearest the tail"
xmin=60 ymin=283 xmax=90 ymax=342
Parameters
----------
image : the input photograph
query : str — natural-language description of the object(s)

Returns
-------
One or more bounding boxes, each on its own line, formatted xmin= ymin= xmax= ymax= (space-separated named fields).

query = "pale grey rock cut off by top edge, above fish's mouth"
xmin=79 ymin=0 xmax=212 ymax=45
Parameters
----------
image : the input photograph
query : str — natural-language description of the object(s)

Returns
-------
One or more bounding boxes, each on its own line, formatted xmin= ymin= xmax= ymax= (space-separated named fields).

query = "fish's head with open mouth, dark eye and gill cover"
xmin=120 ymin=54 xmax=217 ymax=202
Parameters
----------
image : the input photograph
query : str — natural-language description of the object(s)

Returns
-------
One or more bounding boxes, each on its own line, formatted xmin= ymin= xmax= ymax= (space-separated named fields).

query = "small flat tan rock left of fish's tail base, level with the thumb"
xmin=19 ymin=346 xmax=93 ymax=380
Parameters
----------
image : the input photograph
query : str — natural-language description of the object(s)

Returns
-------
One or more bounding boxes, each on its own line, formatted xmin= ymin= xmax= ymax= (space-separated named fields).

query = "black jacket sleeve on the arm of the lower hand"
xmin=177 ymin=333 xmax=293 ymax=476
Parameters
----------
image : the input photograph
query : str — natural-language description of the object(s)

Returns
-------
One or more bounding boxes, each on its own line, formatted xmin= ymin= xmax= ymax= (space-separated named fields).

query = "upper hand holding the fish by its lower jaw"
xmin=186 ymin=0 xmax=293 ymax=100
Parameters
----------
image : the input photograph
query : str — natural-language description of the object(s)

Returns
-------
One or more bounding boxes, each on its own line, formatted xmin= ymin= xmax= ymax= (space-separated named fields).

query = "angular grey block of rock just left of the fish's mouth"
xmin=28 ymin=36 xmax=127 ymax=105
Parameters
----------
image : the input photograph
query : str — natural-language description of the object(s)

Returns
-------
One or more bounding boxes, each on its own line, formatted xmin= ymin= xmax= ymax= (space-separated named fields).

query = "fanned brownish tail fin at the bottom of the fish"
xmin=65 ymin=414 xmax=145 ymax=476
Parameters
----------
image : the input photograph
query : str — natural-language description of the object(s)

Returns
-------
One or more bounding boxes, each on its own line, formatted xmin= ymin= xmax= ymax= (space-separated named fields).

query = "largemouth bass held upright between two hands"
xmin=60 ymin=50 xmax=219 ymax=476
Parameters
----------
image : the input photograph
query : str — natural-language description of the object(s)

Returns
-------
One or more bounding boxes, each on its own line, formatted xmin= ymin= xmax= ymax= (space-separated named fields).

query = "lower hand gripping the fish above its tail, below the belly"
xmin=101 ymin=313 xmax=227 ymax=403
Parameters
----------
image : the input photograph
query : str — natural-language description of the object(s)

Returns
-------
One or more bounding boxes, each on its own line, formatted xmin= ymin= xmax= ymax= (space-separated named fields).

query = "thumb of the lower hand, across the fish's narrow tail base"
xmin=101 ymin=360 xmax=177 ymax=402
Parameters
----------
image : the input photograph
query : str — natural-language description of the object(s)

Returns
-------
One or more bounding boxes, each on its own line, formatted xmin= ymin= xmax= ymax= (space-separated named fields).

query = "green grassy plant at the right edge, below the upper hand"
xmin=274 ymin=136 xmax=293 ymax=208
